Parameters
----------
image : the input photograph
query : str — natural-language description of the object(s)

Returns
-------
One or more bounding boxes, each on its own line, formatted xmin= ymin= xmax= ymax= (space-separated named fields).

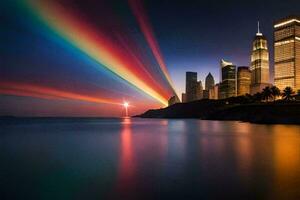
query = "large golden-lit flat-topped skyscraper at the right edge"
xmin=274 ymin=16 xmax=300 ymax=91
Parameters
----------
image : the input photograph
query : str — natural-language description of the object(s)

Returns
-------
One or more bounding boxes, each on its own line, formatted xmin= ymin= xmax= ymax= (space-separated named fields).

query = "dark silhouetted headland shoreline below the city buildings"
xmin=134 ymin=100 xmax=300 ymax=125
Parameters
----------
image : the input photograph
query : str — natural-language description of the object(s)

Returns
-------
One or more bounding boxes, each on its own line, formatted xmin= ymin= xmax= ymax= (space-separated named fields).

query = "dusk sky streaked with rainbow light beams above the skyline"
xmin=0 ymin=0 xmax=300 ymax=117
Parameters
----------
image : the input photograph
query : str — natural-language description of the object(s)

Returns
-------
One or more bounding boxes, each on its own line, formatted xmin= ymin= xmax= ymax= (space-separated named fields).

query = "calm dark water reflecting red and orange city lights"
xmin=0 ymin=119 xmax=300 ymax=200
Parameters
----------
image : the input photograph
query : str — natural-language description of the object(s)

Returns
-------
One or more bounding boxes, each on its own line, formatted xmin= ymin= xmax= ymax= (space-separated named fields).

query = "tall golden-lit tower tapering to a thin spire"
xmin=250 ymin=23 xmax=270 ymax=94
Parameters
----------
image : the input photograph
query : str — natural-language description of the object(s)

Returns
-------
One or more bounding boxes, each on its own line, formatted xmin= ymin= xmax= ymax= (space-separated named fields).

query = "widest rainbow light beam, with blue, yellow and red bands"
xmin=23 ymin=0 xmax=169 ymax=106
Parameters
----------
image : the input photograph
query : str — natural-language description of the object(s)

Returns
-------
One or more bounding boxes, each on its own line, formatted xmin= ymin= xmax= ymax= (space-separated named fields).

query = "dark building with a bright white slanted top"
xmin=219 ymin=59 xmax=236 ymax=99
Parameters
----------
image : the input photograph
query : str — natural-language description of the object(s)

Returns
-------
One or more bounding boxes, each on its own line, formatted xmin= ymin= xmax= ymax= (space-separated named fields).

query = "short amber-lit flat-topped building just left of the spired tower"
xmin=237 ymin=67 xmax=251 ymax=96
